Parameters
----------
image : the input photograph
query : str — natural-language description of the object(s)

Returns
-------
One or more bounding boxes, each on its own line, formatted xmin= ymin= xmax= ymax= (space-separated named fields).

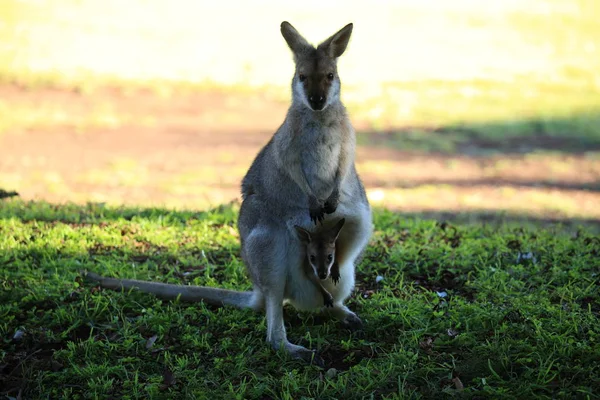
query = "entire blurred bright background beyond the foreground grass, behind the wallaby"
xmin=0 ymin=0 xmax=600 ymax=222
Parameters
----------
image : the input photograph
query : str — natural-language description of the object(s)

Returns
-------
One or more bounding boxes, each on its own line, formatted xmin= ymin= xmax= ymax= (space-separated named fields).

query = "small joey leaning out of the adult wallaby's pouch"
xmin=294 ymin=218 xmax=346 ymax=307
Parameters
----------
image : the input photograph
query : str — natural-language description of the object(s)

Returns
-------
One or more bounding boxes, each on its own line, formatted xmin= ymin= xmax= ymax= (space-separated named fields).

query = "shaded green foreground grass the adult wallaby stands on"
xmin=0 ymin=201 xmax=600 ymax=399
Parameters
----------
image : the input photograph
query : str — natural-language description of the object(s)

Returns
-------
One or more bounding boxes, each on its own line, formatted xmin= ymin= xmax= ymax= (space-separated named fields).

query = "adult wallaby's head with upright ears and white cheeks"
xmin=281 ymin=21 xmax=353 ymax=111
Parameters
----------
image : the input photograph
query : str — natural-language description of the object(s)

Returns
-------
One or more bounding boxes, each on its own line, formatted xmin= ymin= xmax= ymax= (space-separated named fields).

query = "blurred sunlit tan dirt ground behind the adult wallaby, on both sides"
xmin=0 ymin=85 xmax=600 ymax=221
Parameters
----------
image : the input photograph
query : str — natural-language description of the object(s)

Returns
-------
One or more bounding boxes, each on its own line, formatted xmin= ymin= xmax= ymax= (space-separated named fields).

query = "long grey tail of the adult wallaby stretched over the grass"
xmin=83 ymin=272 xmax=259 ymax=308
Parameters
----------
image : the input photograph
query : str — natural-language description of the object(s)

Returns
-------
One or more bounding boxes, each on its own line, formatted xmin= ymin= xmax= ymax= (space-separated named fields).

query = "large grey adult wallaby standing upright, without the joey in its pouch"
xmin=84 ymin=22 xmax=373 ymax=364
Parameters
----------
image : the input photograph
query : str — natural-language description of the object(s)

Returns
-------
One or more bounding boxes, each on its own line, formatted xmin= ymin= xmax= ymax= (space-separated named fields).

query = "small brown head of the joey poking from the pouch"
xmin=295 ymin=218 xmax=346 ymax=279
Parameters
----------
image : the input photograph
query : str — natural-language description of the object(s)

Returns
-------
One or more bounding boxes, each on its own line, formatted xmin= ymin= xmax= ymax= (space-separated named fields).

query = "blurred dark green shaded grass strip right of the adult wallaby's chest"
xmin=358 ymin=113 xmax=600 ymax=157
